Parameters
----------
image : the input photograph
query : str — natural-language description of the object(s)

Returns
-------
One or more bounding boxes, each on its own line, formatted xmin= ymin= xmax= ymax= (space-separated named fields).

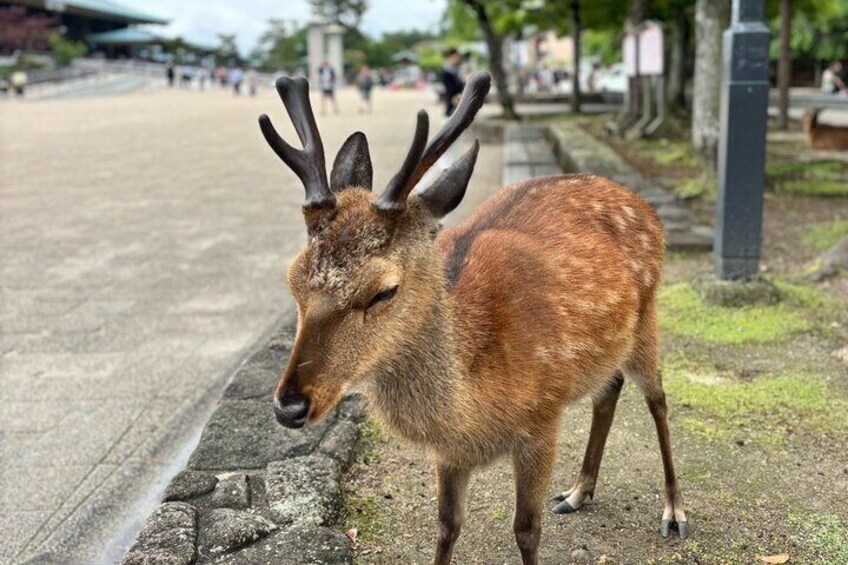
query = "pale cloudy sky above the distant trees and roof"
xmin=132 ymin=0 xmax=447 ymax=54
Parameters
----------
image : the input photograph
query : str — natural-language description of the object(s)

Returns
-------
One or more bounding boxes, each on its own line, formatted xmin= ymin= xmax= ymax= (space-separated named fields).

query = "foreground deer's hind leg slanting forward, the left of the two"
xmin=554 ymin=371 xmax=624 ymax=514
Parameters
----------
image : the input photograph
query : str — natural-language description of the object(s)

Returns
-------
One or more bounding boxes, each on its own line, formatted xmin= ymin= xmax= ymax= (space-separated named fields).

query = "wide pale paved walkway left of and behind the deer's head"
xmin=0 ymin=86 xmax=501 ymax=563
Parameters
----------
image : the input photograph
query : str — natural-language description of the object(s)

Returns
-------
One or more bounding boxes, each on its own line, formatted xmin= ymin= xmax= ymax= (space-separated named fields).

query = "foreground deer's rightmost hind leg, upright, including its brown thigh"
xmin=626 ymin=303 xmax=689 ymax=538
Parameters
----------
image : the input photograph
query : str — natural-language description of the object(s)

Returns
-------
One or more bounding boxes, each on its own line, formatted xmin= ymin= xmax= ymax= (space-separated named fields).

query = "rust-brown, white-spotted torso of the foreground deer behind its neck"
xmin=440 ymin=175 xmax=663 ymax=425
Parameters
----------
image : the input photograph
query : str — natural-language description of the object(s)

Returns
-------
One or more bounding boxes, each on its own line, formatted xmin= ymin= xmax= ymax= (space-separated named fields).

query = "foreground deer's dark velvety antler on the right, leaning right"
xmin=374 ymin=72 xmax=492 ymax=212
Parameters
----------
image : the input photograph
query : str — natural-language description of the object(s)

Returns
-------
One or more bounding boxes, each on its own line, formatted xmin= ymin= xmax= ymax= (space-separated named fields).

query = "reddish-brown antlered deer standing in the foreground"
xmin=259 ymin=72 xmax=689 ymax=565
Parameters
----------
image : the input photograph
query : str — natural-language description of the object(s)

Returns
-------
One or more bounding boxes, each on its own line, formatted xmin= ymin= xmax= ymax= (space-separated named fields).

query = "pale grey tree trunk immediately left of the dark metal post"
xmin=692 ymin=0 xmax=728 ymax=176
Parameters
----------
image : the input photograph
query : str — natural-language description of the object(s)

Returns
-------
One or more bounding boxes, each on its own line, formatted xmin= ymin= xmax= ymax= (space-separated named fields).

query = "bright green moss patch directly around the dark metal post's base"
xmin=659 ymin=283 xmax=812 ymax=344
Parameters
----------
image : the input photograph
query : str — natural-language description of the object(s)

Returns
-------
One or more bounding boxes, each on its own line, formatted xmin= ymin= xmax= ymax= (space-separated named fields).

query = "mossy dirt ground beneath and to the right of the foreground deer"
xmin=340 ymin=117 xmax=848 ymax=565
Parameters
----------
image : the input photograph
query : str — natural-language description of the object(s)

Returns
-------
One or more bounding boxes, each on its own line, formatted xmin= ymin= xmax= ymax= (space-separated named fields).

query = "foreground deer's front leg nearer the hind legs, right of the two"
xmin=513 ymin=422 xmax=558 ymax=565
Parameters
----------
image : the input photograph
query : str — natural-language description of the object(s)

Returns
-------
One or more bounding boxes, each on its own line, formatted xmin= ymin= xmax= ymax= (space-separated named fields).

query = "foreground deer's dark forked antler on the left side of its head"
xmin=259 ymin=77 xmax=336 ymax=210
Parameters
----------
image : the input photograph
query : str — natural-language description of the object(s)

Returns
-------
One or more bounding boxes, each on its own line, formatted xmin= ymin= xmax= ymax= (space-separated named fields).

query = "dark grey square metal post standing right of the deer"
xmin=715 ymin=0 xmax=769 ymax=280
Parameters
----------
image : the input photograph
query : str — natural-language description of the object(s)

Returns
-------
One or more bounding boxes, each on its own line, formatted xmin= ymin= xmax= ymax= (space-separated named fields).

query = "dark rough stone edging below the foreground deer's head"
xmin=123 ymin=324 xmax=364 ymax=565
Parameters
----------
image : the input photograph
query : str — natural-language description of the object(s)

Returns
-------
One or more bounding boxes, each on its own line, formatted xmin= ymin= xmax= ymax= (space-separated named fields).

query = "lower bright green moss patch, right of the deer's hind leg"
xmin=664 ymin=356 xmax=848 ymax=447
